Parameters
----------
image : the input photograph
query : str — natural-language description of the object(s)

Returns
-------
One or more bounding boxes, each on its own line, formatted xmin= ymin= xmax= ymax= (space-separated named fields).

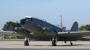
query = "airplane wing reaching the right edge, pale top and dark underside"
xmin=58 ymin=31 xmax=90 ymax=38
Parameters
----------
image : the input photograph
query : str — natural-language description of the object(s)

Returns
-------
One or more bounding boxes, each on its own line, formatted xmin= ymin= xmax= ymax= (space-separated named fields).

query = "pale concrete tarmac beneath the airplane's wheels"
xmin=0 ymin=41 xmax=90 ymax=50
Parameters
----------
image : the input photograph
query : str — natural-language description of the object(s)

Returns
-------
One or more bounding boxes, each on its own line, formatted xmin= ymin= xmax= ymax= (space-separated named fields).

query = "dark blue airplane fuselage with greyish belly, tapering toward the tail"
xmin=23 ymin=18 xmax=62 ymax=35
